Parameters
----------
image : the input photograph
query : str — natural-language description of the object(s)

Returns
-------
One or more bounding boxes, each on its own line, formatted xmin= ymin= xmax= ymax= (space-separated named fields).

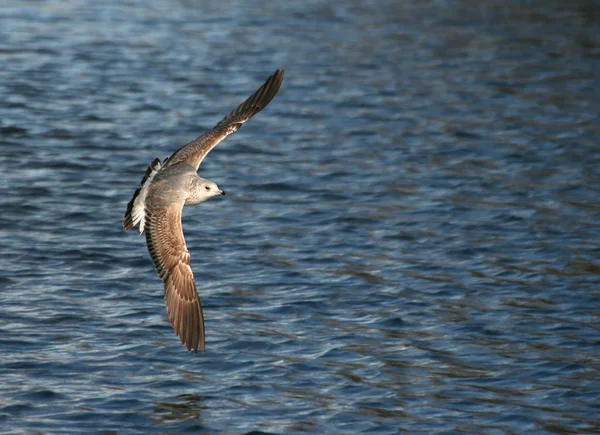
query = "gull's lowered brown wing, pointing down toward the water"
xmin=145 ymin=202 xmax=204 ymax=352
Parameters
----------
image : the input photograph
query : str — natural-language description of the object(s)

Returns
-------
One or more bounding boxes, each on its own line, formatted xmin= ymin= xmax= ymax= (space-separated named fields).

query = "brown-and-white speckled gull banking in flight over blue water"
xmin=123 ymin=69 xmax=285 ymax=353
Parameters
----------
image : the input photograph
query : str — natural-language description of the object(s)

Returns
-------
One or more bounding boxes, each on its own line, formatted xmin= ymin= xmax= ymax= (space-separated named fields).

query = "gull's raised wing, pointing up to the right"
xmin=165 ymin=69 xmax=285 ymax=170
